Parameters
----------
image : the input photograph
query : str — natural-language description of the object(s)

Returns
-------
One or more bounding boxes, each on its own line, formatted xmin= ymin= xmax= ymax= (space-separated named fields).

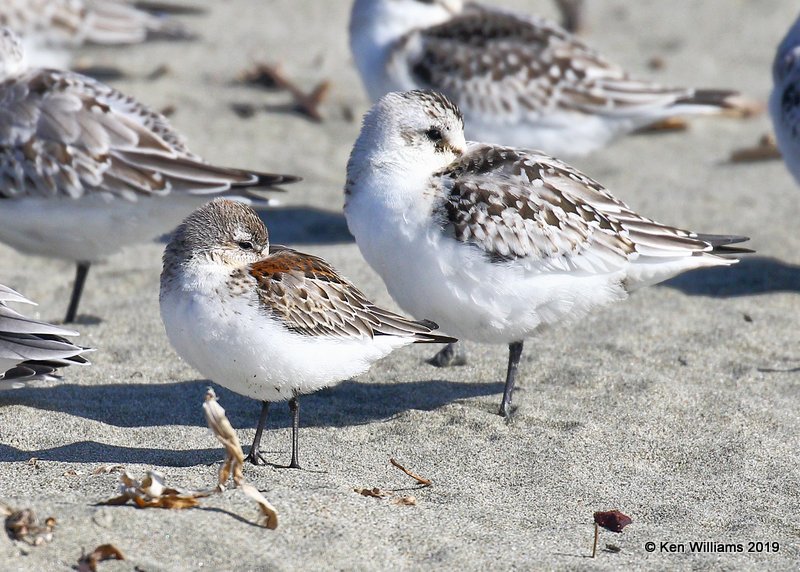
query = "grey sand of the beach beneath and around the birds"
xmin=0 ymin=0 xmax=800 ymax=571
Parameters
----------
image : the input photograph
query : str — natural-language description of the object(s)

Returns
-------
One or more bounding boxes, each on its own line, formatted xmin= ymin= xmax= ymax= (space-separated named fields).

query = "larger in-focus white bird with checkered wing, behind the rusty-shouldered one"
xmin=344 ymin=91 xmax=747 ymax=416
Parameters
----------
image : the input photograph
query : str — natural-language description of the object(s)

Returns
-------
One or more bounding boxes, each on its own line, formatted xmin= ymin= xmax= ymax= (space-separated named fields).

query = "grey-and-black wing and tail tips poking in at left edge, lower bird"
xmin=0 ymin=284 xmax=91 ymax=387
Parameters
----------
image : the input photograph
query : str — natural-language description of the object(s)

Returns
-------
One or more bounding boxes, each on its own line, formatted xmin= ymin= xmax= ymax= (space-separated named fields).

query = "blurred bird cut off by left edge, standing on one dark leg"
xmin=0 ymin=28 xmax=299 ymax=322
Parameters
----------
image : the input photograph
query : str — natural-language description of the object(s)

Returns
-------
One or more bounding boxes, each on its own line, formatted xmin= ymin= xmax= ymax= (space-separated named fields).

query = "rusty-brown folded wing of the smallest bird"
xmin=249 ymin=248 xmax=452 ymax=342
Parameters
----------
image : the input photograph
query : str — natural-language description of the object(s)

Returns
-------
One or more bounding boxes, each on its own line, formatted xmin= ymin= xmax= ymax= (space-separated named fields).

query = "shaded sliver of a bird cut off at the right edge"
xmin=769 ymin=11 xmax=800 ymax=183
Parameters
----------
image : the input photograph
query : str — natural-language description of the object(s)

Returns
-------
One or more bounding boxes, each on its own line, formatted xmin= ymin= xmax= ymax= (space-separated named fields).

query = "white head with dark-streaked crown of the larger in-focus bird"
xmin=348 ymin=90 xmax=466 ymax=176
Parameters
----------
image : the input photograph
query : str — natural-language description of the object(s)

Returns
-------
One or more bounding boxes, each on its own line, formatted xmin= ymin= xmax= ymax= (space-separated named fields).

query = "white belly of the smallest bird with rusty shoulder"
xmin=161 ymin=282 xmax=413 ymax=401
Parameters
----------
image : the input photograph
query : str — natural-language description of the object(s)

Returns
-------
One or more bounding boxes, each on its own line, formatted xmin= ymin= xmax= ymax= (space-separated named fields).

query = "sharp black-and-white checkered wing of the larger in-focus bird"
xmin=431 ymin=144 xmax=738 ymax=273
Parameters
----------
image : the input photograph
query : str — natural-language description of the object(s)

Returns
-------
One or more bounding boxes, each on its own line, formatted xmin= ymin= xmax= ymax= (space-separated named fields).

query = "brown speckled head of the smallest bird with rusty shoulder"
xmin=164 ymin=199 xmax=269 ymax=268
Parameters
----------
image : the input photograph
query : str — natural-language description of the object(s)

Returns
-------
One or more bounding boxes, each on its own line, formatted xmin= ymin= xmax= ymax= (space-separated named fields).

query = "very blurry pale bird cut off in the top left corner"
xmin=0 ymin=0 xmax=191 ymax=69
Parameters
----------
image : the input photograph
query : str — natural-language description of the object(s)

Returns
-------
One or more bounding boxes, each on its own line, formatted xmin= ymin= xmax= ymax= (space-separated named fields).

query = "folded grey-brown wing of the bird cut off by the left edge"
xmin=0 ymin=70 xmax=297 ymax=200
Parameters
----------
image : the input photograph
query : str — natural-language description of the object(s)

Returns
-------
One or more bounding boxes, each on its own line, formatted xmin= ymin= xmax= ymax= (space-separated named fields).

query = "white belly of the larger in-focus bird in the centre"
xmin=346 ymin=197 xmax=627 ymax=344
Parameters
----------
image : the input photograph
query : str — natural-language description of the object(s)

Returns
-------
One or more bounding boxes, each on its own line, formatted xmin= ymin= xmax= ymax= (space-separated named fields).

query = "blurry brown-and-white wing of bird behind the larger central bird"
xmin=388 ymin=5 xmax=720 ymax=123
